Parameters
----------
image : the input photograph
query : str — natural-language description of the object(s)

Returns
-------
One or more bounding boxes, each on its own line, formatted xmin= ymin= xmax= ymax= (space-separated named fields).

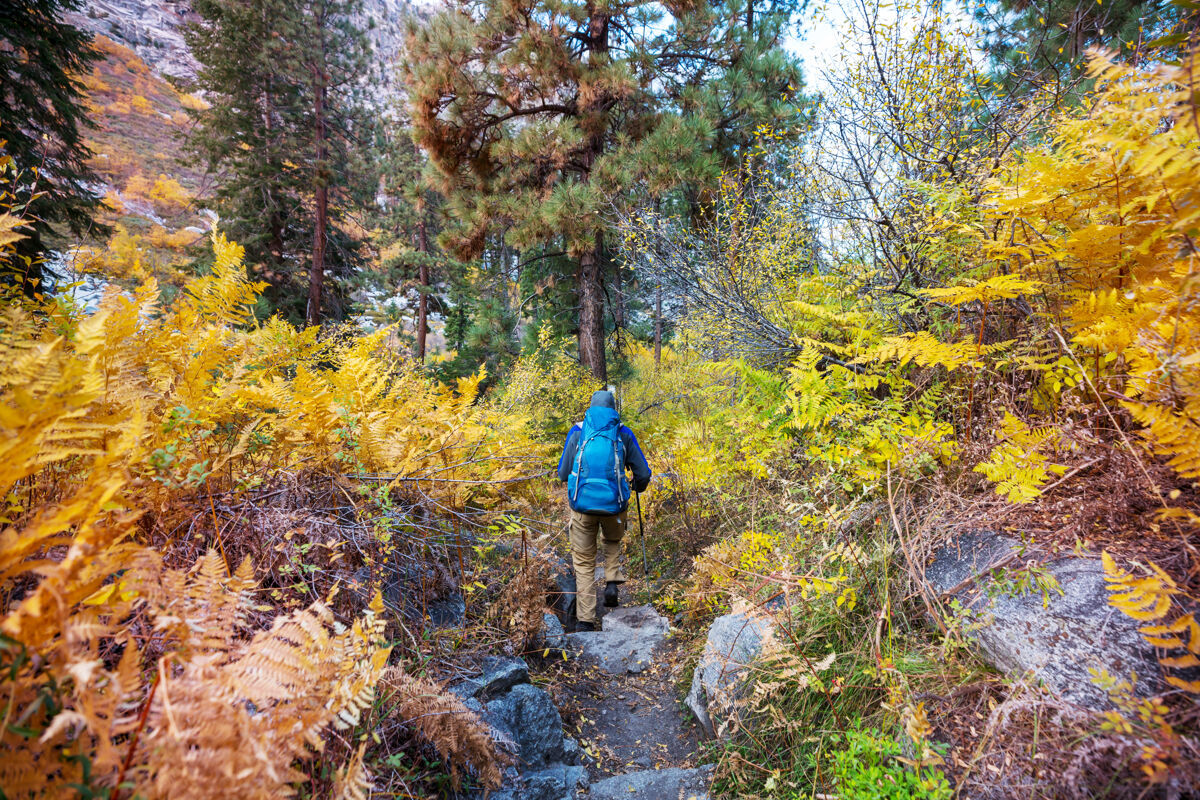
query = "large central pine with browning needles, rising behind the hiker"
xmin=406 ymin=0 xmax=800 ymax=380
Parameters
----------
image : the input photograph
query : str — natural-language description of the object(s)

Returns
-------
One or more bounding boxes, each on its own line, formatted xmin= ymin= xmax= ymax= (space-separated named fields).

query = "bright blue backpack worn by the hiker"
xmin=566 ymin=407 xmax=629 ymax=516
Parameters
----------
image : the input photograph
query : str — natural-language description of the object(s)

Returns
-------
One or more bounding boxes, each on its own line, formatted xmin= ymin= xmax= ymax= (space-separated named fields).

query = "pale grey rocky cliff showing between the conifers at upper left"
xmin=68 ymin=0 xmax=420 ymax=95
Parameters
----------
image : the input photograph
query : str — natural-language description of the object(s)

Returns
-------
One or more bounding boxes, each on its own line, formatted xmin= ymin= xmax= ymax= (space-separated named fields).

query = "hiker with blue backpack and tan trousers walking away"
xmin=558 ymin=390 xmax=650 ymax=631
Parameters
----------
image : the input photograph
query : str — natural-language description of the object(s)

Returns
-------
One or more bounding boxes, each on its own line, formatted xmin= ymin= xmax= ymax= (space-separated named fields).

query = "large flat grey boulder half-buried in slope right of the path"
xmin=925 ymin=530 xmax=1162 ymax=709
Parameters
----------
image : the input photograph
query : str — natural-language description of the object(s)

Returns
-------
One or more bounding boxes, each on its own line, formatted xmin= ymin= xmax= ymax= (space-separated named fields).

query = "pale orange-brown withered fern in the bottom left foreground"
xmin=134 ymin=587 xmax=388 ymax=799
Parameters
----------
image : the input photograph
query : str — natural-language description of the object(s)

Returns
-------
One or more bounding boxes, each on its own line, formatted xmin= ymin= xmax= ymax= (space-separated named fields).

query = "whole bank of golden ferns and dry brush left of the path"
xmin=0 ymin=203 xmax=552 ymax=798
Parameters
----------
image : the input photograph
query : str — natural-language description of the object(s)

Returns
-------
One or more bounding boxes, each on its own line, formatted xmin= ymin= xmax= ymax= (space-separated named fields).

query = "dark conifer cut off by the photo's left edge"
xmin=0 ymin=0 xmax=107 ymax=295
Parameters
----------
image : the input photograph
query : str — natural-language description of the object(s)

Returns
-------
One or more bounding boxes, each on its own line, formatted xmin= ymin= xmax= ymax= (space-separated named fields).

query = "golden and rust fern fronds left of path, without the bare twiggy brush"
xmin=0 ymin=227 xmax=537 ymax=798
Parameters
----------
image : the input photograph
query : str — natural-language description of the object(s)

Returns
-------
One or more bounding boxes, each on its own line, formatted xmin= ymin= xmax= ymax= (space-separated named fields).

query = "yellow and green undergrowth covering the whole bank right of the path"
xmin=624 ymin=40 xmax=1200 ymax=798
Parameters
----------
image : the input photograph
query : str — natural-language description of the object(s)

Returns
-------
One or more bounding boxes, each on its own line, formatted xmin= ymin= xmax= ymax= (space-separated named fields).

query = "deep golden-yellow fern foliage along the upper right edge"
xmin=982 ymin=54 xmax=1200 ymax=479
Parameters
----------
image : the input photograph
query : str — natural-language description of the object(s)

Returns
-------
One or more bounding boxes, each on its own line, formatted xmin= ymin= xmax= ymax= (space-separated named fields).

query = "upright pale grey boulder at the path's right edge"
xmin=684 ymin=612 xmax=774 ymax=736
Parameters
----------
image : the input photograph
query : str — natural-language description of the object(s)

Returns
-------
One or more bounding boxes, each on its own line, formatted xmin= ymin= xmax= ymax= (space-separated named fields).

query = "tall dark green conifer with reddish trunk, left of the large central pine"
xmin=187 ymin=0 xmax=370 ymax=325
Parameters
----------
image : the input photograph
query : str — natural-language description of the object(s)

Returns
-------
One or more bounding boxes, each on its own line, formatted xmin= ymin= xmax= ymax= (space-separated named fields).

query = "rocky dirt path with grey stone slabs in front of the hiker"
xmin=451 ymin=563 xmax=712 ymax=800
